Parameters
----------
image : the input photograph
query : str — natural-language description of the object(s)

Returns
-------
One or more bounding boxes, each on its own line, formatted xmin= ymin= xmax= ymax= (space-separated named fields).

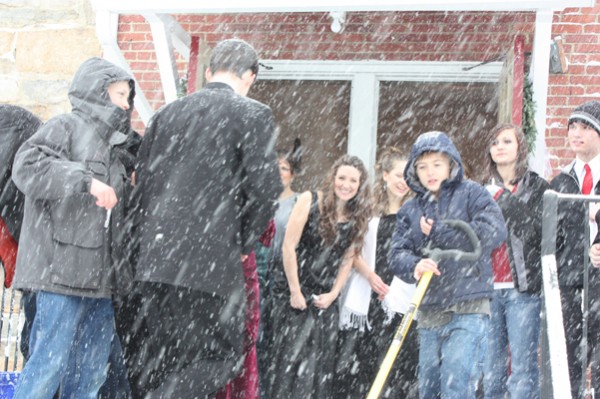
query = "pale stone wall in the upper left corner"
xmin=0 ymin=0 xmax=102 ymax=121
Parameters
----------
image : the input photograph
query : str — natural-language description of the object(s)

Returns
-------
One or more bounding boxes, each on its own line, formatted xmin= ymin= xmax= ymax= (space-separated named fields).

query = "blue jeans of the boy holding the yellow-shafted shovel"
xmin=419 ymin=313 xmax=489 ymax=399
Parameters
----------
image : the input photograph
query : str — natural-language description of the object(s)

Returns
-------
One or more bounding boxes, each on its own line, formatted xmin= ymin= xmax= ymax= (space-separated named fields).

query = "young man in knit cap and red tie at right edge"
xmin=550 ymin=101 xmax=600 ymax=398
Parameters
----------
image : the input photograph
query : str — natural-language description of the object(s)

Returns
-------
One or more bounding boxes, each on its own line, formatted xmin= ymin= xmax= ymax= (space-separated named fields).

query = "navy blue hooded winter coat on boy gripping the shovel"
xmin=390 ymin=132 xmax=507 ymax=310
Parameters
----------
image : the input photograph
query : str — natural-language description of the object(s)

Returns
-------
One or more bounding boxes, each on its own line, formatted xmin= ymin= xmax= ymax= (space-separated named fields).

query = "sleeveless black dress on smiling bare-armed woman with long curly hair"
xmin=267 ymin=193 xmax=351 ymax=399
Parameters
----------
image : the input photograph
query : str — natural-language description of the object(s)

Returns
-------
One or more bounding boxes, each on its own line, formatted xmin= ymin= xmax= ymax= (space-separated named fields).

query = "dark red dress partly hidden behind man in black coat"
xmin=215 ymin=252 xmax=260 ymax=399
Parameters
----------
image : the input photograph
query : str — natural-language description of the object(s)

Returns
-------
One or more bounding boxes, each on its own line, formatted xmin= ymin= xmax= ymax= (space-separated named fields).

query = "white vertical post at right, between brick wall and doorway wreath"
xmin=529 ymin=9 xmax=553 ymax=177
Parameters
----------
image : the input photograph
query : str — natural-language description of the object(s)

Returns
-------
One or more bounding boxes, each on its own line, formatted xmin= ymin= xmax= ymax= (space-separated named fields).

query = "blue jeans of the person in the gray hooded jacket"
xmin=14 ymin=291 xmax=114 ymax=399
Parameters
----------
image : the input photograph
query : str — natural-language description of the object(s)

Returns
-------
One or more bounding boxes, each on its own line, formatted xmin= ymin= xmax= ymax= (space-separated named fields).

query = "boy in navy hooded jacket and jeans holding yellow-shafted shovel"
xmin=390 ymin=132 xmax=507 ymax=399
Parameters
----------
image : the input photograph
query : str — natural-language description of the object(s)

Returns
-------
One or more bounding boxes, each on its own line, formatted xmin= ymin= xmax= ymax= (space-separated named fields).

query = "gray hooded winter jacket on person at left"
xmin=13 ymin=58 xmax=135 ymax=298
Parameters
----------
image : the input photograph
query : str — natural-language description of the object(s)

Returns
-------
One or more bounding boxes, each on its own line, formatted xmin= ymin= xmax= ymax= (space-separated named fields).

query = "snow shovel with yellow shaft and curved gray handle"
xmin=367 ymin=220 xmax=481 ymax=399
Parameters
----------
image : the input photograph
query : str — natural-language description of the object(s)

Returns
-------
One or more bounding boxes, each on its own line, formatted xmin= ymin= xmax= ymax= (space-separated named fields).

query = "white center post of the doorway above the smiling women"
xmin=348 ymin=73 xmax=379 ymax=171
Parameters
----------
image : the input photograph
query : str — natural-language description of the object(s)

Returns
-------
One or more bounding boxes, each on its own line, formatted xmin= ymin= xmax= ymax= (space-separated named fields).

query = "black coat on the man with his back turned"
xmin=132 ymin=83 xmax=282 ymax=296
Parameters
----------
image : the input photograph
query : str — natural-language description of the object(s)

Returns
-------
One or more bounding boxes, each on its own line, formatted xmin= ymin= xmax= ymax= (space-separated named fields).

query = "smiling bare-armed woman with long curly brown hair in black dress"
xmin=268 ymin=155 xmax=370 ymax=399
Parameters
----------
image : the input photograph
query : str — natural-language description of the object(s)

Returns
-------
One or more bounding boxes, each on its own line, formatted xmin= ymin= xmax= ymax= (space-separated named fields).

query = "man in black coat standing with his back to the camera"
xmin=119 ymin=39 xmax=281 ymax=398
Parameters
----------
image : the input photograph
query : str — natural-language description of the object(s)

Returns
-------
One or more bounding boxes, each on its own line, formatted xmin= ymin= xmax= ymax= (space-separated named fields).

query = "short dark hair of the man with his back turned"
xmin=210 ymin=39 xmax=258 ymax=78
